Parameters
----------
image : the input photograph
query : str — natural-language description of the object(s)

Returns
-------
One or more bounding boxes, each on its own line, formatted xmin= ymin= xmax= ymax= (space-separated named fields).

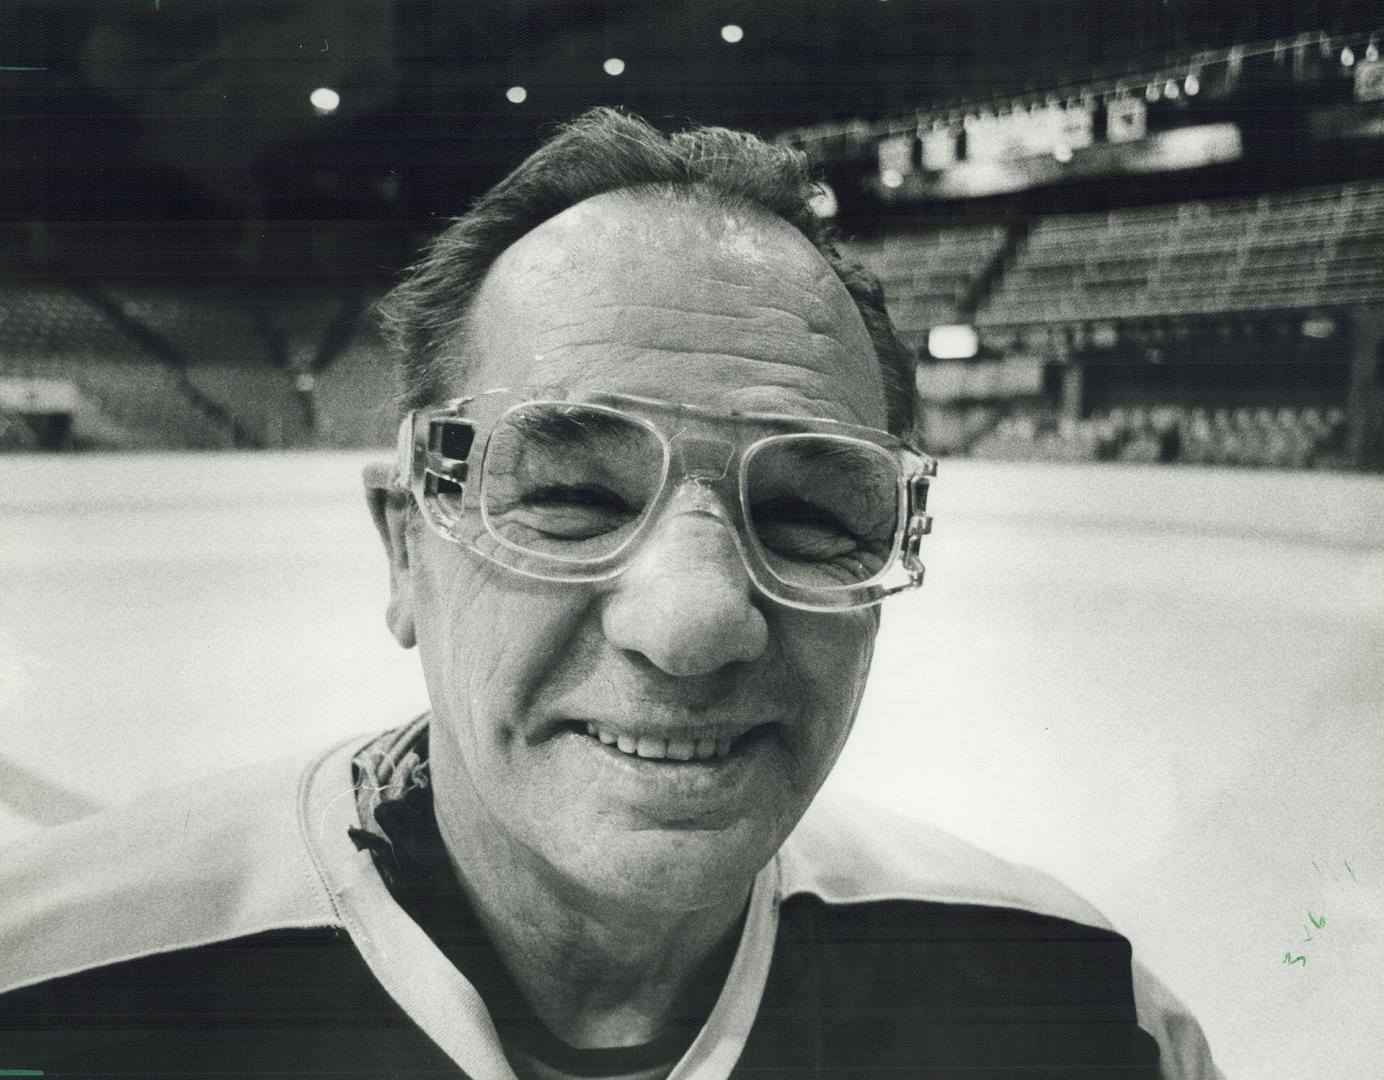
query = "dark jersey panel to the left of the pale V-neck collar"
xmin=0 ymin=928 xmax=461 ymax=1080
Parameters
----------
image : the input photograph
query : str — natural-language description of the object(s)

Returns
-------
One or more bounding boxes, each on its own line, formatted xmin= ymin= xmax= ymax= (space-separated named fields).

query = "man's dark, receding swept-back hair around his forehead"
xmin=381 ymin=108 xmax=913 ymax=433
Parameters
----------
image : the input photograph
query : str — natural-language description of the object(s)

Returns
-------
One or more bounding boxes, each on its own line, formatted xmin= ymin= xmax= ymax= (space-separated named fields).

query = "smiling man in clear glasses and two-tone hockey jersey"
xmin=0 ymin=111 xmax=1215 ymax=1080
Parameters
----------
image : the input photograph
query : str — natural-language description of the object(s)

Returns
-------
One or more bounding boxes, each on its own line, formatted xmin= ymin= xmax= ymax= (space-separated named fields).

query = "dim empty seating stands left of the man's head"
xmin=0 ymin=284 xmax=394 ymax=449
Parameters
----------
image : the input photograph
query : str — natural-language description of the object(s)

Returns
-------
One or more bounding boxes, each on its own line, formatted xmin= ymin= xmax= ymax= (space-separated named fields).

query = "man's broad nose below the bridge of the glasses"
xmin=601 ymin=495 xmax=768 ymax=676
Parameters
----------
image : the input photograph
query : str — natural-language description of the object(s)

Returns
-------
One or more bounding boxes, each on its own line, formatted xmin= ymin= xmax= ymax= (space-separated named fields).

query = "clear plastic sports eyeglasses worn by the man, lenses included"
xmin=397 ymin=388 xmax=937 ymax=611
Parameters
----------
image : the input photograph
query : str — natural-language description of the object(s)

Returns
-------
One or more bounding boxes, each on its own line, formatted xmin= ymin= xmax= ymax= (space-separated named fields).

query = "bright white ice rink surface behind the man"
xmin=0 ymin=453 xmax=1384 ymax=1080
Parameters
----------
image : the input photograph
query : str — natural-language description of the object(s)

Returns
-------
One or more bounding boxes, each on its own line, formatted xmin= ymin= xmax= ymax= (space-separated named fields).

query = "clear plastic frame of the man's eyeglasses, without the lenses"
xmin=394 ymin=386 xmax=937 ymax=613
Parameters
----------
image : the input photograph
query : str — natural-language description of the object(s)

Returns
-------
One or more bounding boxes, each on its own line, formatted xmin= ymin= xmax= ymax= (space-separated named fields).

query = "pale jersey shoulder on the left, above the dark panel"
xmin=0 ymin=755 xmax=336 ymax=993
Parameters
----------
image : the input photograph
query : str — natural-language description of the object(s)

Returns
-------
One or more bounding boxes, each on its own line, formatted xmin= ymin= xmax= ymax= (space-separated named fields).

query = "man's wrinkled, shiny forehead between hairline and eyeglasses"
xmin=458 ymin=192 xmax=884 ymax=426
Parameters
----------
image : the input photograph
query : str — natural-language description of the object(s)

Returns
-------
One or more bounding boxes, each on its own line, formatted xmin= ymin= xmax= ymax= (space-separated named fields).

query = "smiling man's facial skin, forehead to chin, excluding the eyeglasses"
xmin=392 ymin=192 xmax=884 ymax=911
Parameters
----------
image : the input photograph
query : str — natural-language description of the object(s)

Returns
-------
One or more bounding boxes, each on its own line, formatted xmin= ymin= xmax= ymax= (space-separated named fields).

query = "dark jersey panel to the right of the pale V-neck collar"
xmin=736 ymin=896 xmax=1158 ymax=1080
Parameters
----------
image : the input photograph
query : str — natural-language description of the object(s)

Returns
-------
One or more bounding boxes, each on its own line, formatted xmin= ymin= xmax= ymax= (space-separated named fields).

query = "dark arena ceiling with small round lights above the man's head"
xmin=0 ymin=0 xmax=1377 ymax=222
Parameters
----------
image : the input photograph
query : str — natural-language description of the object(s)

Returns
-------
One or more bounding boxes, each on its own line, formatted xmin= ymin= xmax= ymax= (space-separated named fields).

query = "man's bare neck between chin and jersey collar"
xmin=439 ymin=803 xmax=752 ymax=1047
